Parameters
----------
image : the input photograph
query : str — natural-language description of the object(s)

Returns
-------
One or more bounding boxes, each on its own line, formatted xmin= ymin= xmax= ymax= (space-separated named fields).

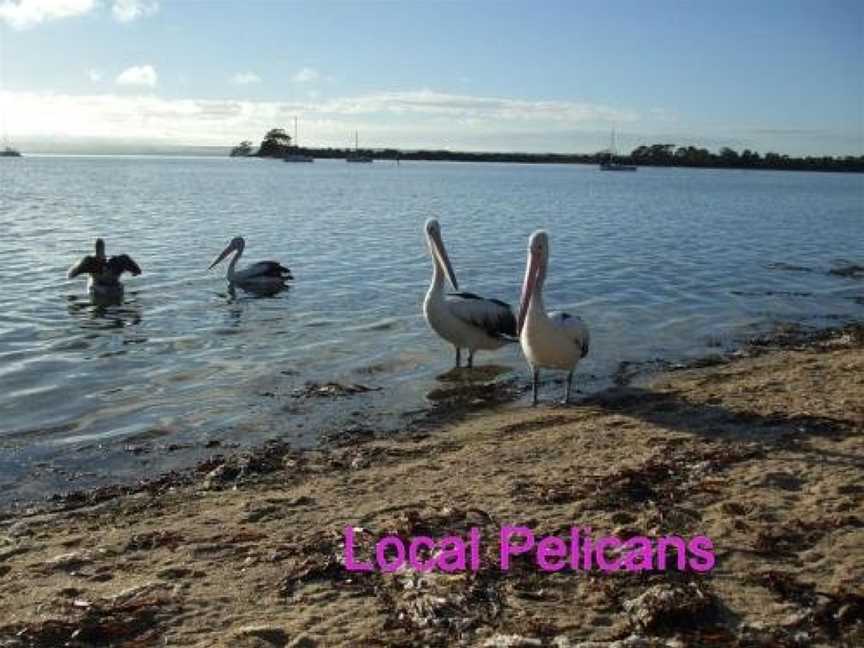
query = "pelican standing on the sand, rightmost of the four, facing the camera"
xmin=518 ymin=230 xmax=589 ymax=405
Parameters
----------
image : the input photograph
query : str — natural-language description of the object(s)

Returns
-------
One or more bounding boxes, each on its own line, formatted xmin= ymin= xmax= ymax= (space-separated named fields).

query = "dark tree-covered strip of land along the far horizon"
xmin=231 ymin=128 xmax=864 ymax=173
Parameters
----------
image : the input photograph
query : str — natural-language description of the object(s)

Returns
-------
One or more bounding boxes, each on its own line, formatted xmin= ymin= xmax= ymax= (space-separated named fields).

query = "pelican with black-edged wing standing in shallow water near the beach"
xmin=423 ymin=218 xmax=516 ymax=368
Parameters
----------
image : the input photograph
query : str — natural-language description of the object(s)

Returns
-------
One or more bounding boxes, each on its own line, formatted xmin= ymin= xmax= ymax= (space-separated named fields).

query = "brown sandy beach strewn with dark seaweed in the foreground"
xmin=0 ymin=327 xmax=864 ymax=648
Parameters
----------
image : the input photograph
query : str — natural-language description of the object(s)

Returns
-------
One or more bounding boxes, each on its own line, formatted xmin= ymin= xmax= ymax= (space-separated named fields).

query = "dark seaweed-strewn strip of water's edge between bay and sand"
xmin=0 ymin=320 xmax=864 ymax=523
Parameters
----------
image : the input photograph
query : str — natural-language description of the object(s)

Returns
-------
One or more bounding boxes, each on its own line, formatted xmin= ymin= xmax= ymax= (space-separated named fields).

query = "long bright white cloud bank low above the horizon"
xmin=2 ymin=88 xmax=638 ymax=152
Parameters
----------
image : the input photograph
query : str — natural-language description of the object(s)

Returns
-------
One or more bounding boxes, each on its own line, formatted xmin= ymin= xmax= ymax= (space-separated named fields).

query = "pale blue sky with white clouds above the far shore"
xmin=0 ymin=0 xmax=864 ymax=155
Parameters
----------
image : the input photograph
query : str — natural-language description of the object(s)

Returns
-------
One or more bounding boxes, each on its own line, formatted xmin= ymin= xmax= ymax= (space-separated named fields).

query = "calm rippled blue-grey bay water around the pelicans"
xmin=0 ymin=157 xmax=864 ymax=500
